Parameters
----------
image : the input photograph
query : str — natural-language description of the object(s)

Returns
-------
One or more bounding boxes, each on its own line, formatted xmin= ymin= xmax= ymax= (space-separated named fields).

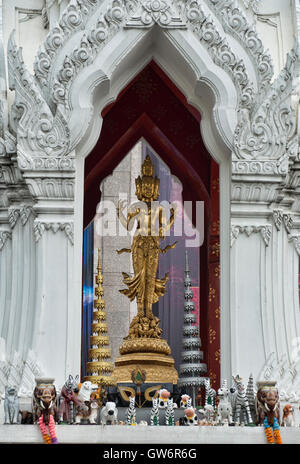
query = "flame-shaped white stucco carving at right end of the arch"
xmin=235 ymin=38 xmax=299 ymax=164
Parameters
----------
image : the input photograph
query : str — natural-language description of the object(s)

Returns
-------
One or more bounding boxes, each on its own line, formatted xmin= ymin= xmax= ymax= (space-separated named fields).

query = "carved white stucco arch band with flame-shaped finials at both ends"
xmin=8 ymin=0 xmax=299 ymax=179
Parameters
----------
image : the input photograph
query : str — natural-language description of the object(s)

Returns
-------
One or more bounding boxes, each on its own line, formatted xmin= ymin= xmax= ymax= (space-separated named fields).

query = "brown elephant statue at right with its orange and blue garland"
xmin=256 ymin=382 xmax=281 ymax=444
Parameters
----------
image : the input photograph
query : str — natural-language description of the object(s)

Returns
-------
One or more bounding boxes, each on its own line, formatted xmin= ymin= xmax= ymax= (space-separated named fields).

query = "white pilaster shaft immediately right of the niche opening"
xmin=231 ymin=225 xmax=270 ymax=378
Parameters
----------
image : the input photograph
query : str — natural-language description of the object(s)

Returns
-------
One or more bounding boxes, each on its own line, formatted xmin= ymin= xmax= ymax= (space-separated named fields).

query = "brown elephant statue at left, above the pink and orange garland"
xmin=32 ymin=382 xmax=57 ymax=425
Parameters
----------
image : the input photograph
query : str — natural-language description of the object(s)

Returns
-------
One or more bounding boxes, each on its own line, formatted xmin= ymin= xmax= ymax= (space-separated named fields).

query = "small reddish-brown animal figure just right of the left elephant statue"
xmin=58 ymin=375 xmax=82 ymax=424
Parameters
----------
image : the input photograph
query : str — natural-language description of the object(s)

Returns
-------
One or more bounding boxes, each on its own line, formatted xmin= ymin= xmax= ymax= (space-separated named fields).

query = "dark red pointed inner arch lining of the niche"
xmin=83 ymin=61 xmax=220 ymax=385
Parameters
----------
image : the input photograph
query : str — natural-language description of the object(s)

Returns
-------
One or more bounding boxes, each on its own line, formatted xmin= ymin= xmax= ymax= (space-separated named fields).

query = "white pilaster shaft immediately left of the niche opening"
xmin=33 ymin=218 xmax=75 ymax=387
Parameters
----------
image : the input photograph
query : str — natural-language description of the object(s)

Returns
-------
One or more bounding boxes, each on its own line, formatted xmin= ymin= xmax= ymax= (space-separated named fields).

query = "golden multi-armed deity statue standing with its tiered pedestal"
xmin=114 ymin=156 xmax=177 ymax=383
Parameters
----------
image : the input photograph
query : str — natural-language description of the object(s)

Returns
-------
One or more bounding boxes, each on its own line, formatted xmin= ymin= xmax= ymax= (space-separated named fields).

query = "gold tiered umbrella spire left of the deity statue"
xmin=84 ymin=248 xmax=116 ymax=387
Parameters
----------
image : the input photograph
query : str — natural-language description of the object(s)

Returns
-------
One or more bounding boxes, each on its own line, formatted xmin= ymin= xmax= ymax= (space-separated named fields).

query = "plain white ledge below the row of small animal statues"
xmin=0 ymin=425 xmax=300 ymax=445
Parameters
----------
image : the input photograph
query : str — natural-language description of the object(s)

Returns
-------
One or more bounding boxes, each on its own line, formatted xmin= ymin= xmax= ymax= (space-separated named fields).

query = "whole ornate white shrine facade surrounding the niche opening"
xmin=0 ymin=0 xmax=300 ymax=410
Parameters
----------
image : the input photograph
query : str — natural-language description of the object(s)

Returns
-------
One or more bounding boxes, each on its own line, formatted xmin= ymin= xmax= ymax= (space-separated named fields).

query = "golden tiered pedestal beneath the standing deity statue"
xmin=113 ymin=338 xmax=178 ymax=384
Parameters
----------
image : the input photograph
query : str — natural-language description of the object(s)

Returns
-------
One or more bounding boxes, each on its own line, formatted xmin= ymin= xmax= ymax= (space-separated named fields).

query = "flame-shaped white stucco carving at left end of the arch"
xmin=8 ymin=33 xmax=72 ymax=170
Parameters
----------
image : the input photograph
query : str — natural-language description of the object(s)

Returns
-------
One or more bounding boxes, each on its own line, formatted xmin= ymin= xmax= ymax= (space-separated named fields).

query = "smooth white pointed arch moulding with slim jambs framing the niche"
xmin=69 ymin=26 xmax=233 ymax=384
